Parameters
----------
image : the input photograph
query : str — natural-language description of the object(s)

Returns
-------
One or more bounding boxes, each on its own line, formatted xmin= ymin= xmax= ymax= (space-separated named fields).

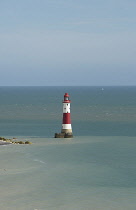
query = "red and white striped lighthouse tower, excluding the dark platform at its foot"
xmin=61 ymin=93 xmax=72 ymax=134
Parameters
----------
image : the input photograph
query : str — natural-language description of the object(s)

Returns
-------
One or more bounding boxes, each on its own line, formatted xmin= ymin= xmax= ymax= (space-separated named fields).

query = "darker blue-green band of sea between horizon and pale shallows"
xmin=0 ymin=87 xmax=136 ymax=137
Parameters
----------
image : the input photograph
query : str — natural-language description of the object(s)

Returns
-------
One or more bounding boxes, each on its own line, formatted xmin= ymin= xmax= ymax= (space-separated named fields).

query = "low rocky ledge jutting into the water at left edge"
xmin=0 ymin=137 xmax=32 ymax=145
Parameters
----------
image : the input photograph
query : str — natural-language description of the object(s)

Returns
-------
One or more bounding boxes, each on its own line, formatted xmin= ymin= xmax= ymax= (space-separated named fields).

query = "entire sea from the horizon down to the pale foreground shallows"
xmin=0 ymin=86 xmax=136 ymax=210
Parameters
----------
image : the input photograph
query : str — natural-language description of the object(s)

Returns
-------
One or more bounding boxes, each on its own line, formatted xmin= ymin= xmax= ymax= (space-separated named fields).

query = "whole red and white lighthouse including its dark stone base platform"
xmin=55 ymin=93 xmax=73 ymax=138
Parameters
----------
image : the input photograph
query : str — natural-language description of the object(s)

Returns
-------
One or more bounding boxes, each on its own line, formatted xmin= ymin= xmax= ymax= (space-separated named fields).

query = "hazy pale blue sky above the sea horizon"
xmin=0 ymin=0 xmax=136 ymax=86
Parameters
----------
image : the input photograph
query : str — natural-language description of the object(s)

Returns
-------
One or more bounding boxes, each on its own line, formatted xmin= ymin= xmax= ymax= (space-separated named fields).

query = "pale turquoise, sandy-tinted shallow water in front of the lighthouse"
xmin=0 ymin=136 xmax=136 ymax=210
